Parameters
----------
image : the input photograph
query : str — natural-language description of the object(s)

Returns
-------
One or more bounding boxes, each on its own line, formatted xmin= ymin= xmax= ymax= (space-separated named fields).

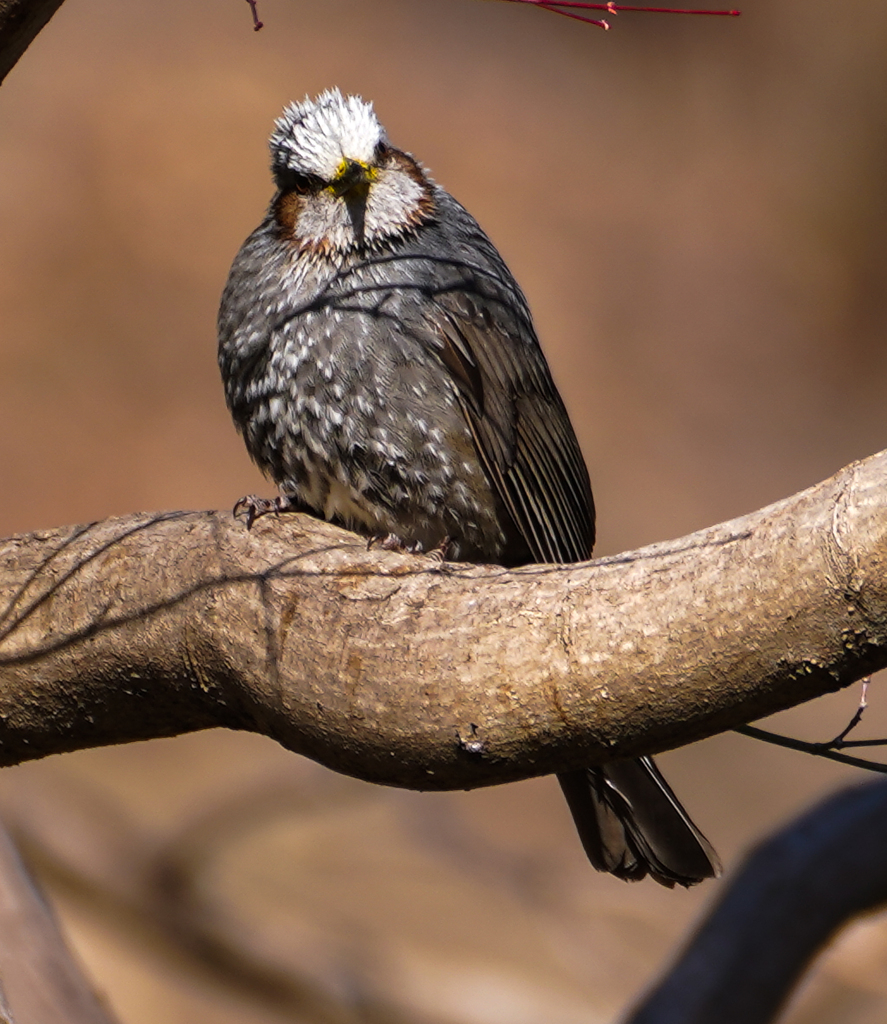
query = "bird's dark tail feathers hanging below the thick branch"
xmin=557 ymin=758 xmax=721 ymax=889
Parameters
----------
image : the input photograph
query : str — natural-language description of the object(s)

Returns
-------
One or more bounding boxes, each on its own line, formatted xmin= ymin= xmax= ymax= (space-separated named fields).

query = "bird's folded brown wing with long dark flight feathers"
xmin=433 ymin=289 xmax=594 ymax=562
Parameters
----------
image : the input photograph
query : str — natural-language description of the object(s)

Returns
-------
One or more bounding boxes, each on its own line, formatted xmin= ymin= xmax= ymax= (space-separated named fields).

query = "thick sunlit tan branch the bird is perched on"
xmin=0 ymin=453 xmax=887 ymax=788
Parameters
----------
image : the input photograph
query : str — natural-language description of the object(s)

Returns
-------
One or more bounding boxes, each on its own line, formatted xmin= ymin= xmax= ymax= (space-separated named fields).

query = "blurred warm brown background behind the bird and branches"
xmin=0 ymin=0 xmax=887 ymax=1024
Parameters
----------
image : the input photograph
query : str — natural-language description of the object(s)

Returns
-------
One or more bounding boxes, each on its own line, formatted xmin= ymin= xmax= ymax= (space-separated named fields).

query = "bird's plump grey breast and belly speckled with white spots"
xmin=219 ymin=190 xmax=518 ymax=558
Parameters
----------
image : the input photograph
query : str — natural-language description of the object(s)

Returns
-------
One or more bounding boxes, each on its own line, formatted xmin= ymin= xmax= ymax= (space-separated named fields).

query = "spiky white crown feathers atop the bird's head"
xmin=269 ymin=89 xmax=385 ymax=181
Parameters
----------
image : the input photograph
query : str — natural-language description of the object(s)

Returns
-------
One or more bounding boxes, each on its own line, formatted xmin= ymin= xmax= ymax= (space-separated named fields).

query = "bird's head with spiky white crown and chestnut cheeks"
xmin=270 ymin=89 xmax=434 ymax=255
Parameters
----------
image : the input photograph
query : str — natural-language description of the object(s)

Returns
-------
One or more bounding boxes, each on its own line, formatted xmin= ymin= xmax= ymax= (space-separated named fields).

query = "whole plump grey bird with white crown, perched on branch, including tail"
xmin=218 ymin=89 xmax=720 ymax=888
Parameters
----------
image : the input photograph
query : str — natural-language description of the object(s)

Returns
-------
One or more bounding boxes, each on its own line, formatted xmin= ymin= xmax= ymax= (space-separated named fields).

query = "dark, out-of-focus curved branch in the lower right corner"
xmin=626 ymin=781 xmax=887 ymax=1024
